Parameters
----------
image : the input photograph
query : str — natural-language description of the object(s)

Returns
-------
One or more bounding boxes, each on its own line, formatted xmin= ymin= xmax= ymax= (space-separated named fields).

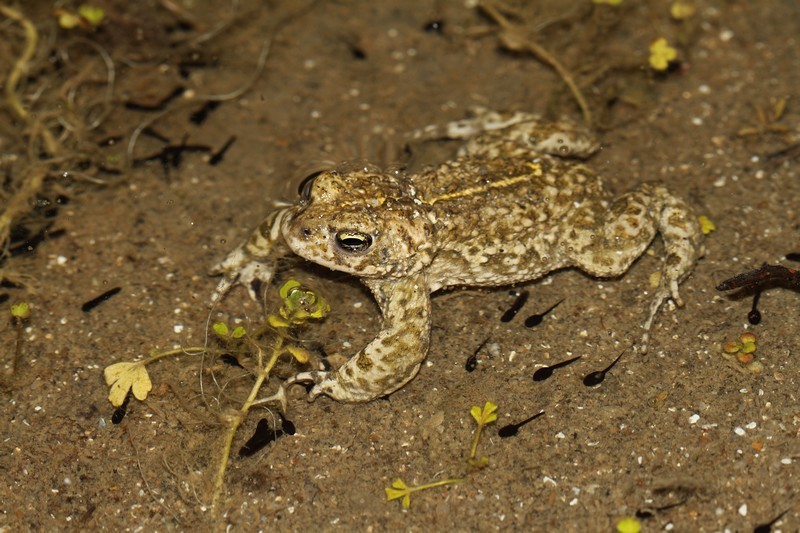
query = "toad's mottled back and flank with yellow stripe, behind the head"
xmin=412 ymin=156 xmax=605 ymax=288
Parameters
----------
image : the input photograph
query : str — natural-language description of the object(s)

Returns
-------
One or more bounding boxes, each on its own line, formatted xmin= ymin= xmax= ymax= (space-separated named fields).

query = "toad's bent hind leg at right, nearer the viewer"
xmin=570 ymin=183 xmax=702 ymax=353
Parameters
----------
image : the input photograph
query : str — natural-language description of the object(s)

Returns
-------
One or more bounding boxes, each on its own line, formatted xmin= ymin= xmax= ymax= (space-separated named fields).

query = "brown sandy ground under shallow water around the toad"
xmin=0 ymin=0 xmax=800 ymax=531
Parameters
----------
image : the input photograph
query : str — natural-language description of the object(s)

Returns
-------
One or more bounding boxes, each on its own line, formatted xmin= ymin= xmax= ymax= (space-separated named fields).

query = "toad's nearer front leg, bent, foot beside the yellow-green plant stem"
xmin=287 ymin=273 xmax=431 ymax=402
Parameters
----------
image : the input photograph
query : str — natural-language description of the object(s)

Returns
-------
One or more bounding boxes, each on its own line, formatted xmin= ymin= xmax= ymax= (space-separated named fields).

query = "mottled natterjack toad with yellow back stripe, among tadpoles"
xmin=212 ymin=110 xmax=701 ymax=402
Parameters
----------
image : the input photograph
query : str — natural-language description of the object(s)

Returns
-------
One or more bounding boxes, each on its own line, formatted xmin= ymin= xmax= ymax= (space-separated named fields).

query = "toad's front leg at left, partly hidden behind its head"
xmin=211 ymin=207 xmax=294 ymax=305
